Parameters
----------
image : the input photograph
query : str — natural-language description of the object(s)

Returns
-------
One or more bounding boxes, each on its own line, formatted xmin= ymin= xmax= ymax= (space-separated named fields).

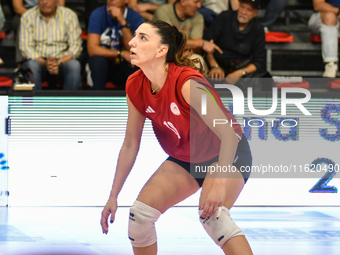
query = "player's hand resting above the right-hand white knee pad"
xmin=200 ymin=181 xmax=226 ymax=218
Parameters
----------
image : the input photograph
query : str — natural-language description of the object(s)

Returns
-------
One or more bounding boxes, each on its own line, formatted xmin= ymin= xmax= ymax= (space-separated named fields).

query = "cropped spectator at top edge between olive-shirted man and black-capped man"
xmin=198 ymin=0 xmax=239 ymax=27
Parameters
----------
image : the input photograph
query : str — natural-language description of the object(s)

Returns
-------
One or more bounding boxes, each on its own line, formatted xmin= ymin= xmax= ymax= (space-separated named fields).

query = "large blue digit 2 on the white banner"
xmin=309 ymin=158 xmax=338 ymax=193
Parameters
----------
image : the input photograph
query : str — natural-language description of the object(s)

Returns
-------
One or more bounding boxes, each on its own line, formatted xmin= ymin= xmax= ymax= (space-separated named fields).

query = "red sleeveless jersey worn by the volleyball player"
xmin=126 ymin=63 xmax=242 ymax=163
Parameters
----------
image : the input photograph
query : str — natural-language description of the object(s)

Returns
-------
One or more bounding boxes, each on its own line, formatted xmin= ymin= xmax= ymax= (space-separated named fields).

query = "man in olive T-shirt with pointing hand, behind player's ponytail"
xmin=153 ymin=0 xmax=222 ymax=67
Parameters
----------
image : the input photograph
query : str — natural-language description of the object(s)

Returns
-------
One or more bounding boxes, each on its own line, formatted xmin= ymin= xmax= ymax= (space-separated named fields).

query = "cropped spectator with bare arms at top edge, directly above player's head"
xmin=128 ymin=0 xmax=175 ymax=20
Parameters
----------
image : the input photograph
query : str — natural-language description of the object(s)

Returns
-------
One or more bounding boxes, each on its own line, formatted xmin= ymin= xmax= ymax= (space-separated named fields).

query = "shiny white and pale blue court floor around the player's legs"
xmin=0 ymin=207 xmax=340 ymax=255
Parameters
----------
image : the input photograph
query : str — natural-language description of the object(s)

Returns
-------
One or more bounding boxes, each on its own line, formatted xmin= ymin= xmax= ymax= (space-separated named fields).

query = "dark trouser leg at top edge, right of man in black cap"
xmin=261 ymin=0 xmax=288 ymax=31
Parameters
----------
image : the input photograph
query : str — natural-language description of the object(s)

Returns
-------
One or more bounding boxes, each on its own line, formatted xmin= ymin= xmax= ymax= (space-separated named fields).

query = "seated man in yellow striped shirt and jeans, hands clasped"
xmin=19 ymin=0 xmax=82 ymax=90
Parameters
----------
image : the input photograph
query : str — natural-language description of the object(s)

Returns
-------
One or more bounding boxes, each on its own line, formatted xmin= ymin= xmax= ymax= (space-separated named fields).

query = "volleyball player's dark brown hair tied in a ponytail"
xmin=145 ymin=20 xmax=203 ymax=74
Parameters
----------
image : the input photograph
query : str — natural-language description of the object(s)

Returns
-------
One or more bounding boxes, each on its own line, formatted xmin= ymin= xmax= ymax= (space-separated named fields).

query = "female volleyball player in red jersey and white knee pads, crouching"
xmin=101 ymin=21 xmax=252 ymax=255
